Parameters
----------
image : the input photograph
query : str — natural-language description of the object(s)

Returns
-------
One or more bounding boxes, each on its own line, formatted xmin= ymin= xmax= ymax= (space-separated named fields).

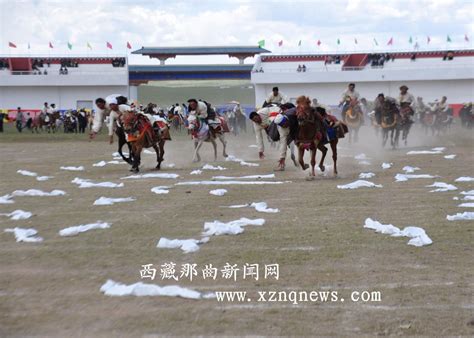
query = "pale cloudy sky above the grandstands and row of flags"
xmin=0 ymin=0 xmax=474 ymax=64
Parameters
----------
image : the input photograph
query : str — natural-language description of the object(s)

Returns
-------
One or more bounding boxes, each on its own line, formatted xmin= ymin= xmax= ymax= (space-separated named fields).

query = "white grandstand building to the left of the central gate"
xmin=0 ymin=57 xmax=130 ymax=111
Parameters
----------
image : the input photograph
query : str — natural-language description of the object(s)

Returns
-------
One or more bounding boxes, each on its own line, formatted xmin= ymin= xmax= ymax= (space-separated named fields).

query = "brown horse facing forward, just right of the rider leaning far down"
xmin=295 ymin=96 xmax=323 ymax=178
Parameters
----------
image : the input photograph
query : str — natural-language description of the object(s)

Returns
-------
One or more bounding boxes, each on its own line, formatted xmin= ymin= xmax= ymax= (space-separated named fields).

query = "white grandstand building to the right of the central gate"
xmin=251 ymin=50 xmax=474 ymax=106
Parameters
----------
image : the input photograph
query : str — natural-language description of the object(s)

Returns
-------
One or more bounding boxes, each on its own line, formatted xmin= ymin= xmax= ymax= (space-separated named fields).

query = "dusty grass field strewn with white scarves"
xmin=0 ymin=122 xmax=474 ymax=337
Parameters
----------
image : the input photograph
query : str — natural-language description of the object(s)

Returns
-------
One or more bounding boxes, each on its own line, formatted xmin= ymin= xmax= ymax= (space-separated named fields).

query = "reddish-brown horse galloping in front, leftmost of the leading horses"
xmin=117 ymin=111 xmax=171 ymax=173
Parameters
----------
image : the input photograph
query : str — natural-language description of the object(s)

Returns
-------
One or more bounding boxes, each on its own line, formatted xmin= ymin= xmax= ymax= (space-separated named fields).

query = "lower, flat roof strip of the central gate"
xmin=128 ymin=65 xmax=253 ymax=73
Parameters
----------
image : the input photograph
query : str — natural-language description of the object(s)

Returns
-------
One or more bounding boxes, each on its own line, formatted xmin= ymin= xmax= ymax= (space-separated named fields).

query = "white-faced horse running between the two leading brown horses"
xmin=188 ymin=115 xmax=229 ymax=162
